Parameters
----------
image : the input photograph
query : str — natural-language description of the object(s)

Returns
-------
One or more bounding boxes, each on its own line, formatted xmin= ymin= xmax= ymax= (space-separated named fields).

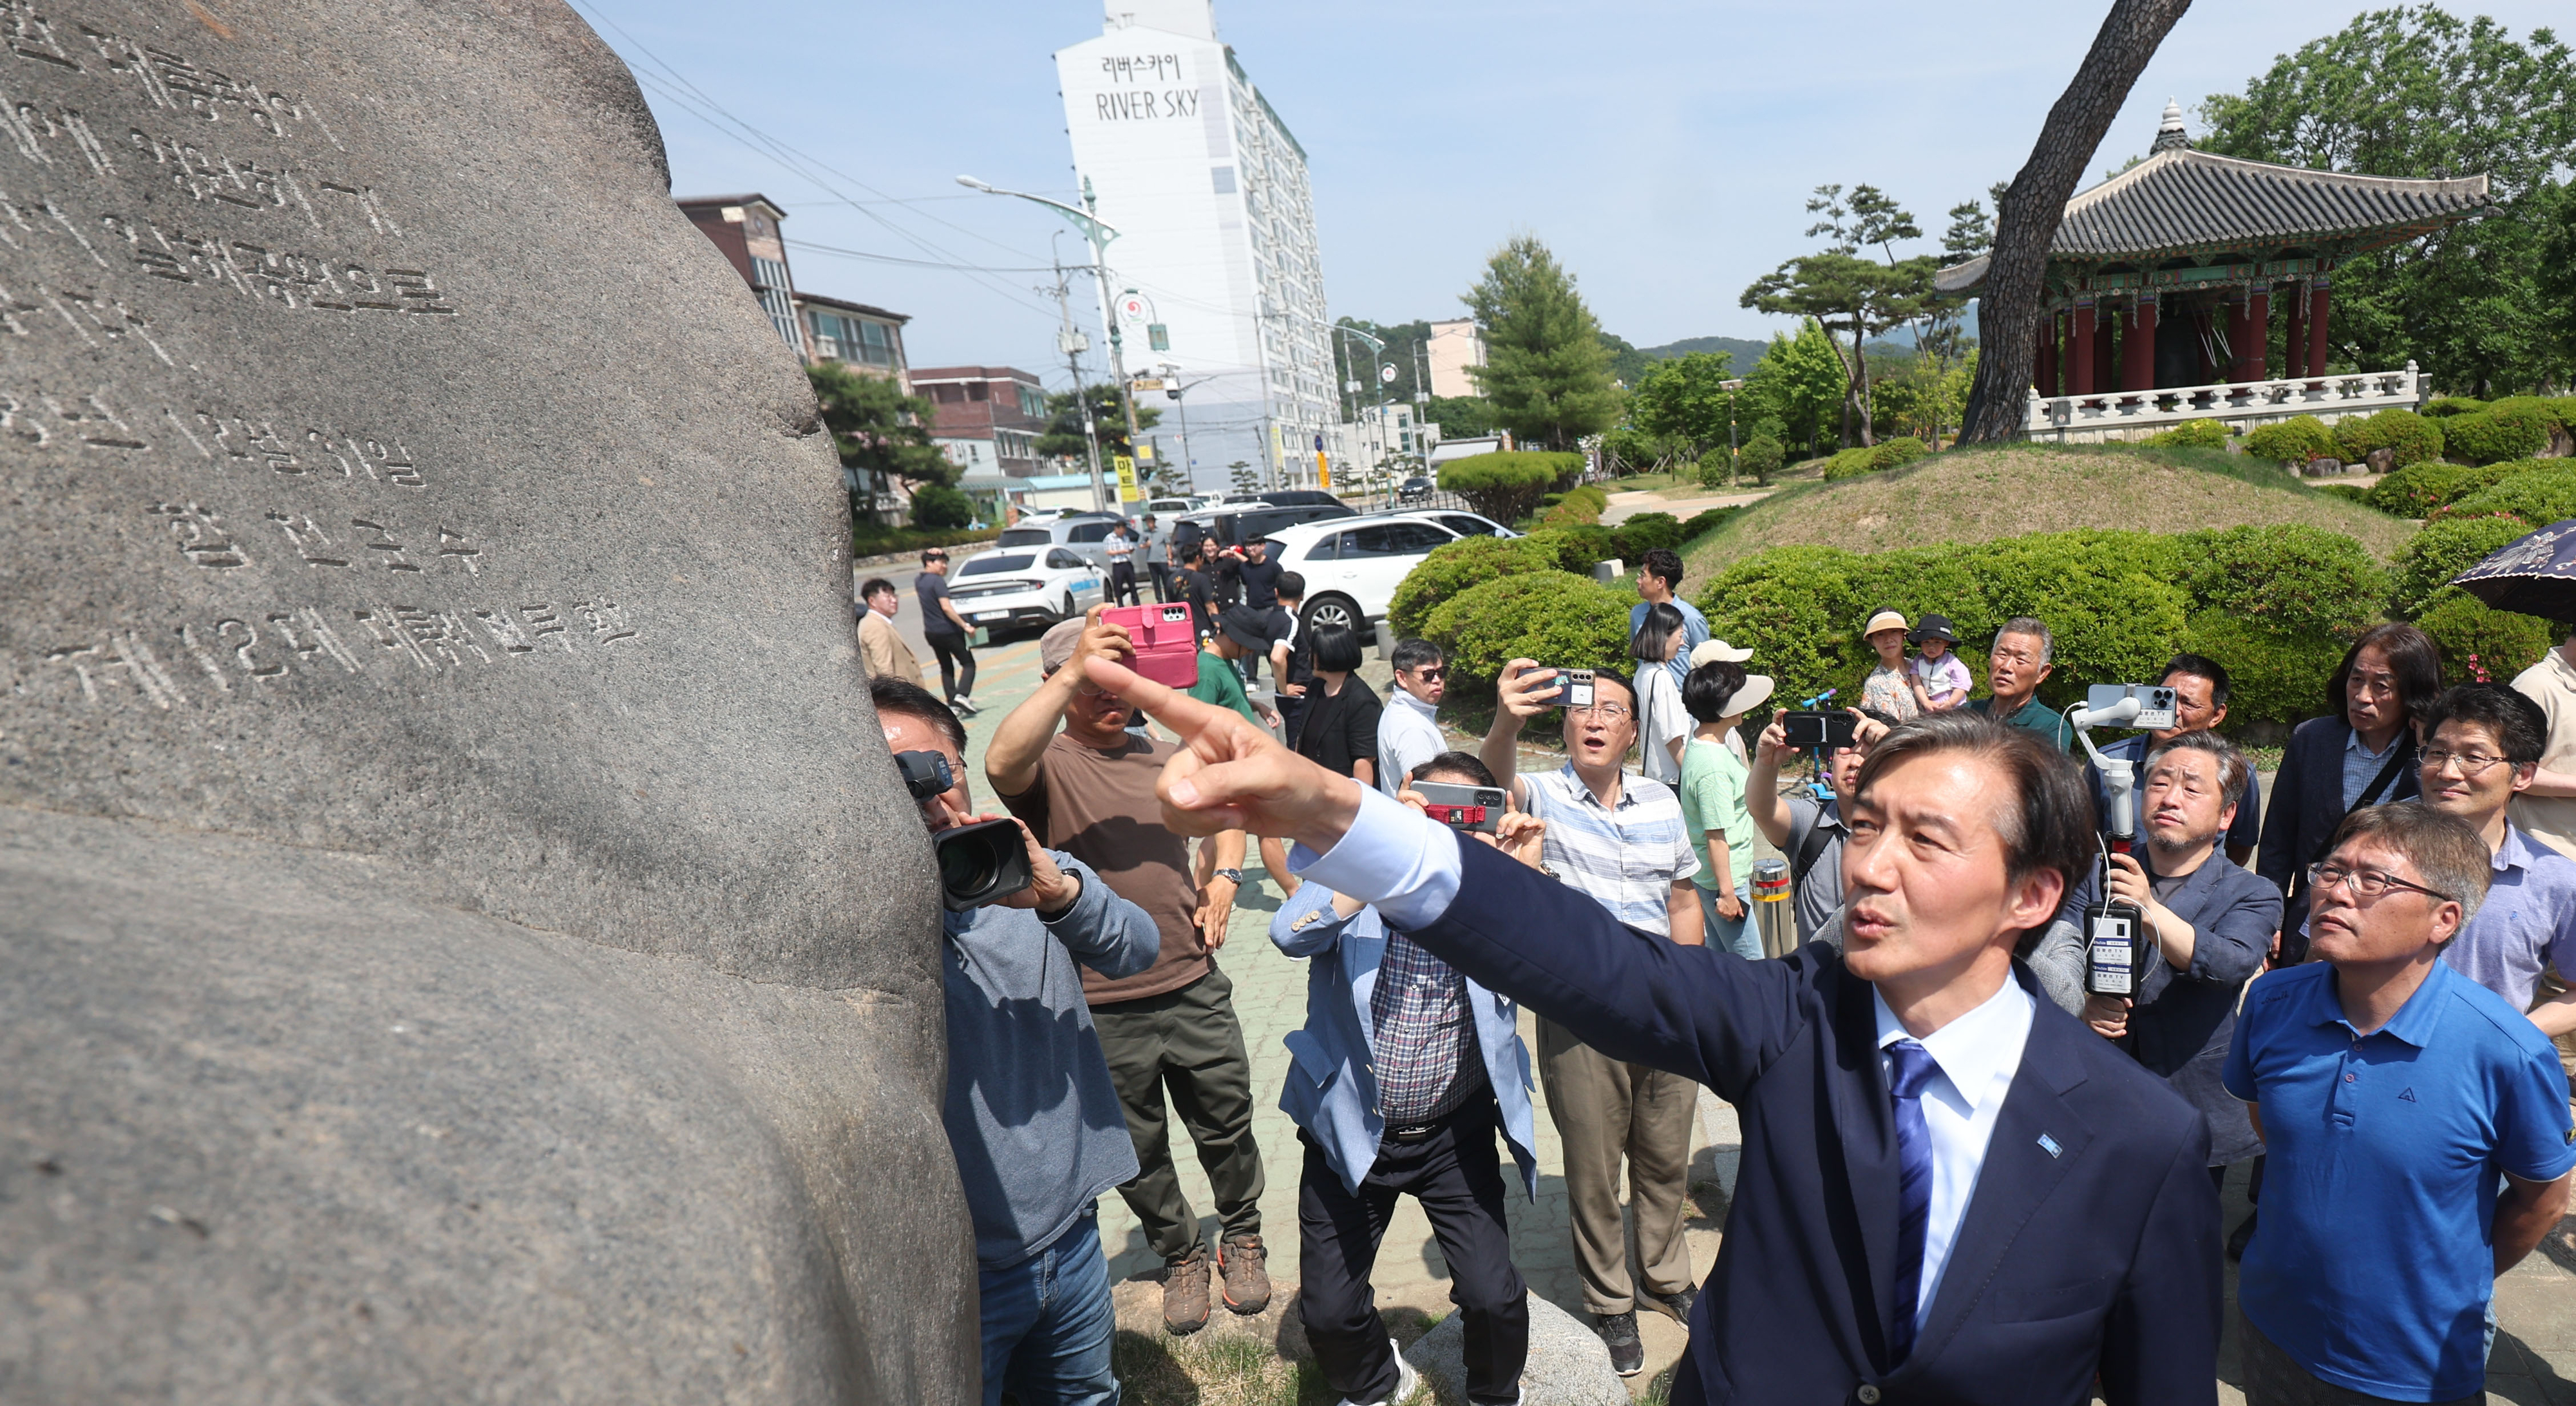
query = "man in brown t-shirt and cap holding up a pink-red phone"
xmin=984 ymin=605 xmax=1270 ymax=1334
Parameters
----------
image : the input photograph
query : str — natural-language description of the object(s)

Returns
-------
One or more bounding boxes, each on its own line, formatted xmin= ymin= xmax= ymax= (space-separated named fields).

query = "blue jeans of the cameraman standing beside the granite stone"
xmin=976 ymin=1215 xmax=1118 ymax=1406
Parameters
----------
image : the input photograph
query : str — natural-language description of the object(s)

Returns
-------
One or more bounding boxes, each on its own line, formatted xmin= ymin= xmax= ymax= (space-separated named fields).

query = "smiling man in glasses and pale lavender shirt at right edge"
xmin=2419 ymin=682 xmax=2576 ymax=1038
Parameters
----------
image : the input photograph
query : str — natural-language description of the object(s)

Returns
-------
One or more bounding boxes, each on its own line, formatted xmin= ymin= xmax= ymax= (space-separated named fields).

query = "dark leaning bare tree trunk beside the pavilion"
xmin=1958 ymin=0 xmax=2192 ymax=443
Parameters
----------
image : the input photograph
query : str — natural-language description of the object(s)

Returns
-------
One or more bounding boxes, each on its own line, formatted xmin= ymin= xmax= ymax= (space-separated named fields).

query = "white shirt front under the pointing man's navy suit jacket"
xmin=1870 ymin=973 xmax=2038 ymax=1329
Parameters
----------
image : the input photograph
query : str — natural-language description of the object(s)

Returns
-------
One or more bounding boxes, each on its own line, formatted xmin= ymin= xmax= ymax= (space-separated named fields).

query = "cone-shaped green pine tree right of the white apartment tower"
xmin=1466 ymin=234 xmax=1620 ymax=448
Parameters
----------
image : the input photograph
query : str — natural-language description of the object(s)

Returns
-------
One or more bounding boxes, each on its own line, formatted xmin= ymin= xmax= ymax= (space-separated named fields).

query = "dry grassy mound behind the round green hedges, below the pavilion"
xmin=1687 ymin=445 xmax=2414 ymax=569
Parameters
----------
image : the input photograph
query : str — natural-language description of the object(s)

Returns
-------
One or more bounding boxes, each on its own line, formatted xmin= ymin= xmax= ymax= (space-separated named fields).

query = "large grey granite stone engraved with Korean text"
xmin=0 ymin=0 xmax=976 ymax=1403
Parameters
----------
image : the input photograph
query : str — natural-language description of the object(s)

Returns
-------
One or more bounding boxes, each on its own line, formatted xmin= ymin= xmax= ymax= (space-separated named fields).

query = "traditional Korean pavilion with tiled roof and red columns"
xmin=1937 ymin=103 xmax=2488 ymax=438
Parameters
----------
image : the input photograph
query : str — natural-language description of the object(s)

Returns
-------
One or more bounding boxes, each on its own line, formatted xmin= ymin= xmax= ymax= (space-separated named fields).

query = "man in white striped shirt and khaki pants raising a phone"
xmin=1484 ymin=659 xmax=1700 ymax=1375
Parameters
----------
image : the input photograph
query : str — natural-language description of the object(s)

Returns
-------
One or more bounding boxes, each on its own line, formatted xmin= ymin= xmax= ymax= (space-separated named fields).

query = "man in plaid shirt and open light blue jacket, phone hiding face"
xmin=1270 ymin=752 xmax=1546 ymax=1403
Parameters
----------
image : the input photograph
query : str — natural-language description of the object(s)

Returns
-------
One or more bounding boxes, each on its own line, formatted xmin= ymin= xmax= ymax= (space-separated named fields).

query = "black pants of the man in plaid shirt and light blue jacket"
xmin=1296 ymin=1094 xmax=1530 ymax=1401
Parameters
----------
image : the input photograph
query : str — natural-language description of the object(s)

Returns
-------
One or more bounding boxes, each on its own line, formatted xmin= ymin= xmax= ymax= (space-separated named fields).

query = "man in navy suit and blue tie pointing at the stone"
xmin=1087 ymin=659 xmax=2221 ymax=1406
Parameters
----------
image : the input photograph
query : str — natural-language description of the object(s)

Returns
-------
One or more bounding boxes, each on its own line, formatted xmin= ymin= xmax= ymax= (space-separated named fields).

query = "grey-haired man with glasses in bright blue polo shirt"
xmin=2223 ymin=803 xmax=2576 ymax=1406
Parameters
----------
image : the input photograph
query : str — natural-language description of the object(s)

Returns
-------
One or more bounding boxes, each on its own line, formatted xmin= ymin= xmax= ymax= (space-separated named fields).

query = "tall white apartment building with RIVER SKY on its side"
xmin=1056 ymin=0 xmax=1347 ymax=489
